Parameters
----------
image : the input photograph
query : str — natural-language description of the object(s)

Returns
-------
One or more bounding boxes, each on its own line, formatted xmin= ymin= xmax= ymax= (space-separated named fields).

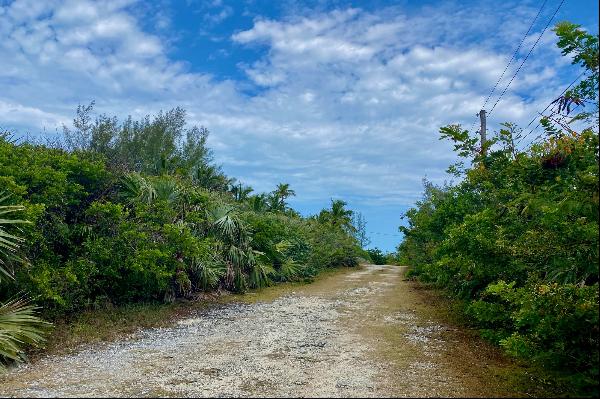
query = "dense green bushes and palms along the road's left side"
xmin=0 ymin=104 xmax=365 ymax=364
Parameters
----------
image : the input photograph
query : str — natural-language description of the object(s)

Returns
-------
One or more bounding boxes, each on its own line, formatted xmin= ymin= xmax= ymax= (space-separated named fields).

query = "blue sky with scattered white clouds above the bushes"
xmin=0 ymin=0 xmax=598 ymax=250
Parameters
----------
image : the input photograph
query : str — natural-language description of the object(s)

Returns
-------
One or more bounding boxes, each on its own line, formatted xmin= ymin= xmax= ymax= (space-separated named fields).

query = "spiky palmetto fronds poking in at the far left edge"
xmin=0 ymin=192 xmax=49 ymax=369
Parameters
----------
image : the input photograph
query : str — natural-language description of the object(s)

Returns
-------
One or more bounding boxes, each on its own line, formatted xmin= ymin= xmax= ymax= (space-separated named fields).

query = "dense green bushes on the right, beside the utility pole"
xmin=398 ymin=22 xmax=599 ymax=396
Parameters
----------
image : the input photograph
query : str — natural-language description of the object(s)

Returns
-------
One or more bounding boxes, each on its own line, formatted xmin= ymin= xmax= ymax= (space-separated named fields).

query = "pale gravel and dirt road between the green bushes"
xmin=0 ymin=265 xmax=518 ymax=397
